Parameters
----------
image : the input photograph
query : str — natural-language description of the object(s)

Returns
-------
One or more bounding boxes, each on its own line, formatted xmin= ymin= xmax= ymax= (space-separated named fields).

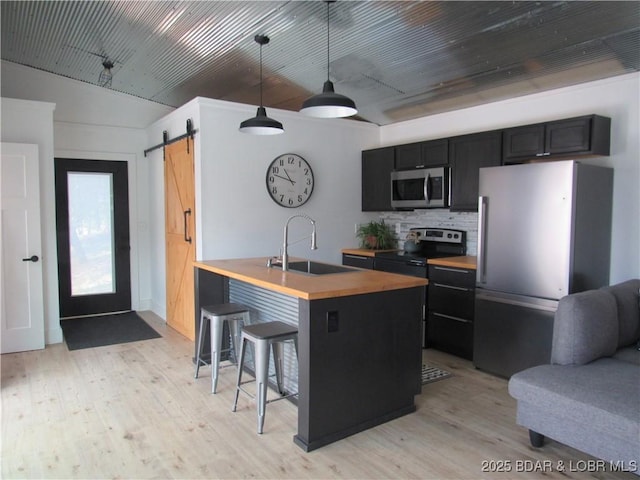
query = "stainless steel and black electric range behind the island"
xmin=373 ymin=228 xmax=467 ymax=348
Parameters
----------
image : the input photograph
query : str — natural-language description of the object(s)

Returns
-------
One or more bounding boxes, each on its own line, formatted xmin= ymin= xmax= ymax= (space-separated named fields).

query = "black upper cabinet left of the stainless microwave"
xmin=362 ymin=147 xmax=395 ymax=212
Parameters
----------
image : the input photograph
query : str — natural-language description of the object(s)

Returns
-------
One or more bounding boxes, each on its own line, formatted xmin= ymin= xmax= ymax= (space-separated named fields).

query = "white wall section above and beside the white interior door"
xmin=0 ymin=98 xmax=62 ymax=343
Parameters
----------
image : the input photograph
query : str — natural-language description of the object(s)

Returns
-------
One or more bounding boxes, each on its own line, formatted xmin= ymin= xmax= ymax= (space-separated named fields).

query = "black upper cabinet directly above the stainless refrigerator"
xmin=503 ymin=115 xmax=611 ymax=163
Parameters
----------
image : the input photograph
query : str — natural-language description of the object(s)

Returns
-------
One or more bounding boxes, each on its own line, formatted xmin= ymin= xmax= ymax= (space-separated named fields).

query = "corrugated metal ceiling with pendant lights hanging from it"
xmin=0 ymin=0 xmax=640 ymax=125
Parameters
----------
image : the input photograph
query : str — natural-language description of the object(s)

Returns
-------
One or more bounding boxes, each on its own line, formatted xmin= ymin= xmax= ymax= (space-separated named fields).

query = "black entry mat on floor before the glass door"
xmin=60 ymin=312 xmax=162 ymax=350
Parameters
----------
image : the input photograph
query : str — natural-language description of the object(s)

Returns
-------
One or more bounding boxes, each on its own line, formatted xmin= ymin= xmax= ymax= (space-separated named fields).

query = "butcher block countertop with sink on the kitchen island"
xmin=193 ymin=257 xmax=428 ymax=300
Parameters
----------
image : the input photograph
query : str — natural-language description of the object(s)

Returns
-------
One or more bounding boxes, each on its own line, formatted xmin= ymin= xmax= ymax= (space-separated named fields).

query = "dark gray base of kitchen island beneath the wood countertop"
xmin=195 ymin=261 xmax=425 ymax=452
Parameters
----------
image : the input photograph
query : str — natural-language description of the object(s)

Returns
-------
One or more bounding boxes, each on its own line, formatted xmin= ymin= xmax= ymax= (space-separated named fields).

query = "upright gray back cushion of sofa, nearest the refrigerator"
xmin=551 ymin=290 xmax=618 ymax=365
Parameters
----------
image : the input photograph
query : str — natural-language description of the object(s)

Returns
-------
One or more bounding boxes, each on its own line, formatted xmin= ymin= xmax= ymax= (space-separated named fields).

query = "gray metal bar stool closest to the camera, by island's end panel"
xmin=231 ymin=322 xmax=298 ymax=433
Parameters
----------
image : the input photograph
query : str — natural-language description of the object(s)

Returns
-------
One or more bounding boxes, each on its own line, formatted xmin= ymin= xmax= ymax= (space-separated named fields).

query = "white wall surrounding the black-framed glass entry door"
xmin=1 ymin=61 xmax=173 ymax=343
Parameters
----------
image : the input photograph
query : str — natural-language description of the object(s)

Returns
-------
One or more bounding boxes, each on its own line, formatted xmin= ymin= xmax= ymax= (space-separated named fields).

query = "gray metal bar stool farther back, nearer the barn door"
xmin=194 ymin=303 xmax=249 ymax=393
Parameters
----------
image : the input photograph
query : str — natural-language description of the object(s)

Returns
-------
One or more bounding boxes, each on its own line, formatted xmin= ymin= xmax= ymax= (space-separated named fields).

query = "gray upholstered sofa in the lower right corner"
xmin=509 ymin=280 xmax=640 ymax=475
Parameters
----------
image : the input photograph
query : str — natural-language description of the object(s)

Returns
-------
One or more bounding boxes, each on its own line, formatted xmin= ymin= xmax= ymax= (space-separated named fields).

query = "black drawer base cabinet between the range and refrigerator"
xmin=427 ymin=265 xmax=475 ymax=360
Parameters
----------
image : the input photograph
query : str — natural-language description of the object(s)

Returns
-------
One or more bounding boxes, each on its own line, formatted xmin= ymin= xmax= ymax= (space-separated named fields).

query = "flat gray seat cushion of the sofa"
xmin=509 ymin=358 xmax=640 ymax=442
